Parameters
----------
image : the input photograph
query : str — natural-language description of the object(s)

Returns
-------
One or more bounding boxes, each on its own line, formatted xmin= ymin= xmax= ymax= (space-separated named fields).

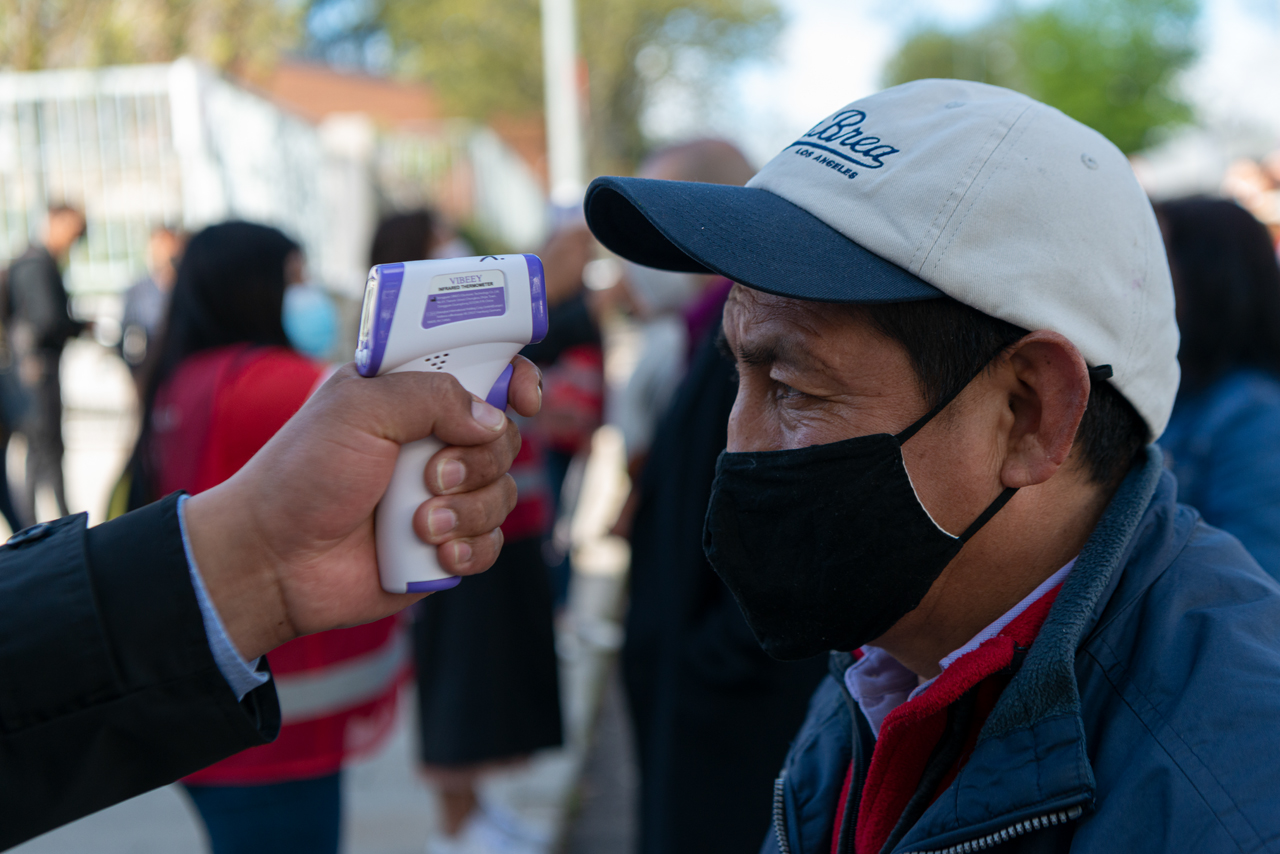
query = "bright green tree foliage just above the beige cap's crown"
xmin=884 ymin=0 xmax=1198 ymax=152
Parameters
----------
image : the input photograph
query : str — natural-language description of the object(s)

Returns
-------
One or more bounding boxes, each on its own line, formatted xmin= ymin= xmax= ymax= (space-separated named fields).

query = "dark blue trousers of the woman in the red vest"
xmin=186 ymin=772 xmax=342 ymax=854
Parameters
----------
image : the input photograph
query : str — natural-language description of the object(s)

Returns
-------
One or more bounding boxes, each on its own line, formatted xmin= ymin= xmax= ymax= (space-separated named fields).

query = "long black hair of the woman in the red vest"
xmin=129 ymin=222 xmax=300 ymax=508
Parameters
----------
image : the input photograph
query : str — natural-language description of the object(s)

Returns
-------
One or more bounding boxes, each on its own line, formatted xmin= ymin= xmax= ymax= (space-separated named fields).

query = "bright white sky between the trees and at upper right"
xmin=646 ymin=0 xmax=1280 ymax=164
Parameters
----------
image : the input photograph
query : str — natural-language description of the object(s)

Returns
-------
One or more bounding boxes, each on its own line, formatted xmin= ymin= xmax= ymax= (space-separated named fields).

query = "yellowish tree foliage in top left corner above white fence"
xmin=0 ymin=0 xmax=302 ymax=74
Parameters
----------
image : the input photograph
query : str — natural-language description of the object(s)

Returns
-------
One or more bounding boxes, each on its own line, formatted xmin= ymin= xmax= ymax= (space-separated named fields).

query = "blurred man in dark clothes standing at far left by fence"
xmin=6 ymin=204 xmax=87 ymax=524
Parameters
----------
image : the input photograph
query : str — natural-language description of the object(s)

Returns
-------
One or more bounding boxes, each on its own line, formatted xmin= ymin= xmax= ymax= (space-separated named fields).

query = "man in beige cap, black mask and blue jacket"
xmin=586 ymin=81 xmax=1280 ymax=854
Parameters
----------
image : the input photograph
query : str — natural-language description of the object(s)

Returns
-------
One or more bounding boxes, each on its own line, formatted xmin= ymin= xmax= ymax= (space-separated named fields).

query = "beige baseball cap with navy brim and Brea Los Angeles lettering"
xmin=585 ymin=79 xmax=1179 ymax=438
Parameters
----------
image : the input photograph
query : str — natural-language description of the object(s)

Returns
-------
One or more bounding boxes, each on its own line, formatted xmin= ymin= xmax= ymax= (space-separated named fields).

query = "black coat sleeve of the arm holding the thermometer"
xmin=0 ymin=495 xmax=280 ymax=849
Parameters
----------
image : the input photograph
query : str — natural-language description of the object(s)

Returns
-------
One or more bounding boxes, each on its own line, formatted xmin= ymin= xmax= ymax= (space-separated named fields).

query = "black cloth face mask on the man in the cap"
xmin=703 ymin=376 xmax=1018 ymax=661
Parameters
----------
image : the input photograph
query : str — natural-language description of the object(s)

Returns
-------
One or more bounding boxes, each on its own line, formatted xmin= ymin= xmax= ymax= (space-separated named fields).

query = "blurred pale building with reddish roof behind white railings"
xmin=0 ymin=59 xmax=545 ymax=296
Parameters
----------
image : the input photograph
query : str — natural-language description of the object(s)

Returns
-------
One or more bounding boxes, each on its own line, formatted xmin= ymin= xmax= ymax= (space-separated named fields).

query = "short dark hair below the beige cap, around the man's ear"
xmin=851 ymin=297 xmax=1148 ymax=487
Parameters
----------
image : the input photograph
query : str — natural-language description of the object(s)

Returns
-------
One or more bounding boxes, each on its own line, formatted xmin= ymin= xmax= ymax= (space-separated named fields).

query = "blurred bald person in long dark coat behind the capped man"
xmin=620 ymin=140 xmax=827 ymax=854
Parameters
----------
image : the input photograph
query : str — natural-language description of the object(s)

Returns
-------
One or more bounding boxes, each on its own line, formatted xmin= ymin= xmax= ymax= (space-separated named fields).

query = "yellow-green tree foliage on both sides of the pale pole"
xmin=366 ymin=0 xmax=781 ymax=170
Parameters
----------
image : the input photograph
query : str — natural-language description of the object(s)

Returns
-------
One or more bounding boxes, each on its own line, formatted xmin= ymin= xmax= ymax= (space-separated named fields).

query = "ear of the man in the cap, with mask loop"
xmin=1000 ymin=329 xmax=1089 ymax=488
